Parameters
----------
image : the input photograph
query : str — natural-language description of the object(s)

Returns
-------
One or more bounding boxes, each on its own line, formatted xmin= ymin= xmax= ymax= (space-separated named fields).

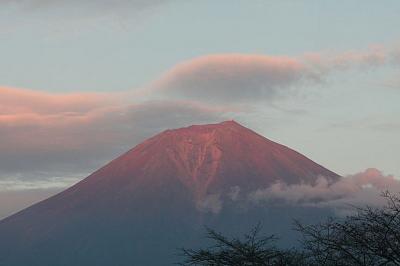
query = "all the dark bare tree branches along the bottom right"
xmin=181 ymin=192 xmax=400 ymax=266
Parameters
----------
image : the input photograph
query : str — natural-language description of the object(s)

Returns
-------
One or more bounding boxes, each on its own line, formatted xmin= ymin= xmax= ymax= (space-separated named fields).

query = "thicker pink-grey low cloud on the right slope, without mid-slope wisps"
xmin=248 ymin=168 xmax=400 ymax=213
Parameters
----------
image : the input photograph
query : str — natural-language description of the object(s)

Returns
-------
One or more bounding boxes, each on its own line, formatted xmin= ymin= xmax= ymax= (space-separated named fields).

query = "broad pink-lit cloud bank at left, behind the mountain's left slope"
xmin=0 ymin=88 xmax=227 ymax=179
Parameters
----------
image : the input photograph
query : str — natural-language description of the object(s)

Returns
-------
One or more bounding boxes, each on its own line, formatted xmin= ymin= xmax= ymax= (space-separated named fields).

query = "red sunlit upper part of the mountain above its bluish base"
xmin=75 ymin=121 xmax=338 ymax=198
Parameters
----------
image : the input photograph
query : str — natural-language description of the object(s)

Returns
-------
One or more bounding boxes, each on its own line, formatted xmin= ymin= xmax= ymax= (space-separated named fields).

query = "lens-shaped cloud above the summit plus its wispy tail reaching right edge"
xmin=151 ymin=45 xmax=400 ymax=103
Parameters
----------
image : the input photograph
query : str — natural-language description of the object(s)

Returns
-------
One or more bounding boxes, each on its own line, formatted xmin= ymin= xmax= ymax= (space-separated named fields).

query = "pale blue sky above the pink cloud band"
xmin=0 ymin=0 xmax=400 ymax=91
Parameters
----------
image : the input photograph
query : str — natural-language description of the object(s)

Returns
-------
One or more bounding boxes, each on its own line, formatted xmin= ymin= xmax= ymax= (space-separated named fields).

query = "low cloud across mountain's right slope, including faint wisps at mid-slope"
xmin=191 ymin=168 xmax=400 ymax=215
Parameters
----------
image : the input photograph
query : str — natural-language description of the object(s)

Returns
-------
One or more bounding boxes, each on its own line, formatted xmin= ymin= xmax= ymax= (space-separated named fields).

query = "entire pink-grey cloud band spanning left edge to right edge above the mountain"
xmin=0 ymin=42 xmax=399 ymax=191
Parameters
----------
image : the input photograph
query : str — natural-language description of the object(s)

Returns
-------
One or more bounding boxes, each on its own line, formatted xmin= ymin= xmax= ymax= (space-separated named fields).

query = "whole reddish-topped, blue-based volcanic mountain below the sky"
xmin=0 ymin=121 xmax=340 ymax=266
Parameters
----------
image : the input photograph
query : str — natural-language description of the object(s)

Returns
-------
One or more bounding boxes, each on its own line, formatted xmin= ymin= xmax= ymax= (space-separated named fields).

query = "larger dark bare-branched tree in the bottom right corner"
xmin=296 ymin=192 xmax=400 ymax=266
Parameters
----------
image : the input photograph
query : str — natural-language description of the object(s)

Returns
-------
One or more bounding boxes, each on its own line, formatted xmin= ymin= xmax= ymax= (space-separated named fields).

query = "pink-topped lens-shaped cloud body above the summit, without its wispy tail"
xmin=152 ymin=54 xmax=309 ymax=102
